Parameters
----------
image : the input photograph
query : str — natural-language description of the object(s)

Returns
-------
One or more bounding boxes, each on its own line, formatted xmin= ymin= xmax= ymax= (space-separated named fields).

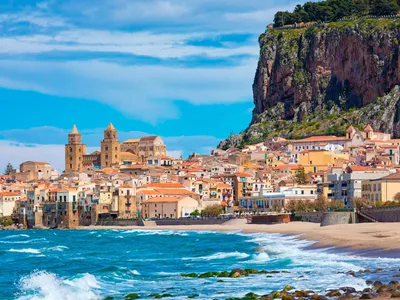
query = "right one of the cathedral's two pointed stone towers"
xmin=101 ymin=123 xmax=121 ymax=168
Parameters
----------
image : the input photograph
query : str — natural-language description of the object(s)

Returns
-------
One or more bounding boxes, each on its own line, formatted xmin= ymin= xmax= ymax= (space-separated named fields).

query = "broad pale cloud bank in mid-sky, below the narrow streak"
xmin=0 ymin=59 xmax=256 ymax=124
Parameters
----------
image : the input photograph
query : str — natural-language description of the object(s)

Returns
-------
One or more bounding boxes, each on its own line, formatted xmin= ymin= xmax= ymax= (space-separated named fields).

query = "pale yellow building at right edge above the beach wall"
xmin=361 ymin=173 xmax=400 ymax=202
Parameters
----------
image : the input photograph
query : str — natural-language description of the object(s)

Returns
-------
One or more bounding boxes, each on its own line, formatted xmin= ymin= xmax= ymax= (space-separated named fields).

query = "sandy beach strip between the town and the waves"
xmin=79 ymin=219 xmax=400 ymax=253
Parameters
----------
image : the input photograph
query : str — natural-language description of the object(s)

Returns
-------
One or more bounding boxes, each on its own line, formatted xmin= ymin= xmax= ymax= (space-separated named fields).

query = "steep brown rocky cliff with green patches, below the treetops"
xmin=219 ymin=18 xmax=400 ymax=148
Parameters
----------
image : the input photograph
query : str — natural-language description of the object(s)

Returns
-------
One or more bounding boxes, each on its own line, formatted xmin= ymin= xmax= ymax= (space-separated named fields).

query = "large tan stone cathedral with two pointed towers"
xmin=65 ymin=123 xmax=167 ymax=173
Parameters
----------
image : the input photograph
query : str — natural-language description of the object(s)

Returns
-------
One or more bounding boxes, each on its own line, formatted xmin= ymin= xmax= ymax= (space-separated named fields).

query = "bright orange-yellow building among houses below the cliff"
xmin=299 ymin=150 xmax=349 ymax=173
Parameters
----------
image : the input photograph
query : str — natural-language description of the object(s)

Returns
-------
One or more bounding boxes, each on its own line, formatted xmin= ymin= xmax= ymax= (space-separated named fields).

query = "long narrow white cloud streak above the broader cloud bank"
xmin=0 ymin=30 xmax=258 ymax=59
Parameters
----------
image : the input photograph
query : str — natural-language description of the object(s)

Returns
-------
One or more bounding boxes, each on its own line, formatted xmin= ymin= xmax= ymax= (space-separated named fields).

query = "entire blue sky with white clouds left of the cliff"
xmin=0 ymin=0 xmax=304 ymax=173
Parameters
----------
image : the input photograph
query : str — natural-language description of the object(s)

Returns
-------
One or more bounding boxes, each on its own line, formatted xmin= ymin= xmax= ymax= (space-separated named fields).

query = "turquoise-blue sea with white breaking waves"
xmin=0 ymin=230 xmax=400 ymax=300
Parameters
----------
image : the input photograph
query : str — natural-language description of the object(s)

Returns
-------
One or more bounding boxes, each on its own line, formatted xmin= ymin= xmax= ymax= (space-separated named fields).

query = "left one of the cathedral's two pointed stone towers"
xmin=65 ymin=125 xmax=86 ymax=173
